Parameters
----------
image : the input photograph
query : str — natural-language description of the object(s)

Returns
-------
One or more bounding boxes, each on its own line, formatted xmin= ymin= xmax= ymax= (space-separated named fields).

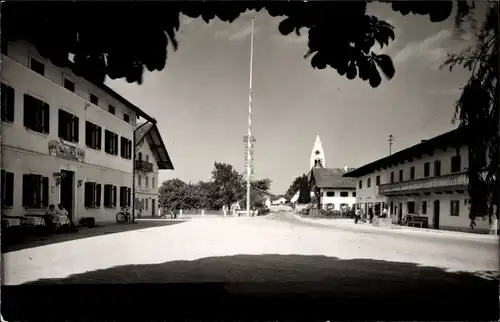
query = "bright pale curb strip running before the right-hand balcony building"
xmin=291 ymin=213 xmax=499 ymax=242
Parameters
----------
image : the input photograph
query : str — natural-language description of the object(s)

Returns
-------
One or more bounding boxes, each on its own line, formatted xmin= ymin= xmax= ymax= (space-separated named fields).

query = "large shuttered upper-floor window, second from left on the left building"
xmin=24 ymin=94 xmax=50 ymax=134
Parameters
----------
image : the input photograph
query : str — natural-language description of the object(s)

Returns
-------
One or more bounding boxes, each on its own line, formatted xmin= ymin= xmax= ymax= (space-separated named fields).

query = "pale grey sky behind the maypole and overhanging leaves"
xmin=106 ymin=3 xmax=471 ymax=194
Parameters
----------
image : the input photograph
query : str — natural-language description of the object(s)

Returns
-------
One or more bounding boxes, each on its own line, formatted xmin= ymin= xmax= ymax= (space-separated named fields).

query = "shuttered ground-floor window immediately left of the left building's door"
xmin=23 ymin=174 xmax=49 ymax=209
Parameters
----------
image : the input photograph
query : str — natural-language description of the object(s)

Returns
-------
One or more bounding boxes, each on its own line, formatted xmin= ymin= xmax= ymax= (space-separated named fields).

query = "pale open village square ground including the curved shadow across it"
xmin=3 ymin=213 xmax=499 ymax=320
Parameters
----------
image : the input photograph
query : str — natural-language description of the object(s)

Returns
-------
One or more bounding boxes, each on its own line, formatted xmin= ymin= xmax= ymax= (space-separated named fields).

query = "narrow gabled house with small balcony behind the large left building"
xmin=135 ymin=122 xmax=174 ymax=217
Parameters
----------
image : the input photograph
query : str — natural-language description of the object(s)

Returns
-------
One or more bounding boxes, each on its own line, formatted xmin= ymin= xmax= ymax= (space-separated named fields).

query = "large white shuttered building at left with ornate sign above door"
xmin=1 ymin=41 xmax=156 ymax=222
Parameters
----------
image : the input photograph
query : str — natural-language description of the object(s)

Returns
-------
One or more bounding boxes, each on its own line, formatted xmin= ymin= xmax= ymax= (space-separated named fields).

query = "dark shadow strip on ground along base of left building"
xmin=2 ymin=220 xmax=185 ymax=254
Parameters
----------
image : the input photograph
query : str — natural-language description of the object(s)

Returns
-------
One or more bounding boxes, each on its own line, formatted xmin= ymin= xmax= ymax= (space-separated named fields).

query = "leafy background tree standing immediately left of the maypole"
xmin=212 ymin=162 xmax=245 ymax=208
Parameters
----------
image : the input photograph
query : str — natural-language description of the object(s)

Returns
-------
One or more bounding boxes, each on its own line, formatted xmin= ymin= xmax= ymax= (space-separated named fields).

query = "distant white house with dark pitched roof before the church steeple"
xmin=309 ymin=167 xmax=356 ymax=210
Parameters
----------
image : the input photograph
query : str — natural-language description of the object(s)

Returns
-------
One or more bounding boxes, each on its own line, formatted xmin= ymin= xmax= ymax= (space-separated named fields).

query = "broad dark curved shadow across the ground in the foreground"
xmin=2 ymin=255 xmax=499 ymax=321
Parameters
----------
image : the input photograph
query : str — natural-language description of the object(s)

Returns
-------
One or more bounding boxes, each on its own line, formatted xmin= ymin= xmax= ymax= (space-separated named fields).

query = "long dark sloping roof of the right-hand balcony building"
xmin=344 ymin=127 xmax=466 ymax=178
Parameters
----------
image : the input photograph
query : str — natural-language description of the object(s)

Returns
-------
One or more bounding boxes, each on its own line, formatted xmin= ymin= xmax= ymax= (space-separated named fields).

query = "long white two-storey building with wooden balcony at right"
xmin=344 ymin=129 xmax=490 ymax=232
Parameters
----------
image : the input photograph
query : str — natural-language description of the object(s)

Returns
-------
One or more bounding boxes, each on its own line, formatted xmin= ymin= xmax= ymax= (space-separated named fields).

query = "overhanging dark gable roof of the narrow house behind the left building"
xmin=135 ymin=123 xmax=174 ymax=170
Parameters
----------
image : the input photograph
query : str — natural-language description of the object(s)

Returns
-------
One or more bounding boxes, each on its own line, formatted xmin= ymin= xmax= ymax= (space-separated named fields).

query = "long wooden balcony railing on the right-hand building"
xmin=378 ymin=172 xmax=469 ymax=195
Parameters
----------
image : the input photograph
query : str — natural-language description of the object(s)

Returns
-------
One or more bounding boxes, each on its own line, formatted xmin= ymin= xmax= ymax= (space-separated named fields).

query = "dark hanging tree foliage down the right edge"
xmin=442 ymin=1 xmax=500 ymax=223
